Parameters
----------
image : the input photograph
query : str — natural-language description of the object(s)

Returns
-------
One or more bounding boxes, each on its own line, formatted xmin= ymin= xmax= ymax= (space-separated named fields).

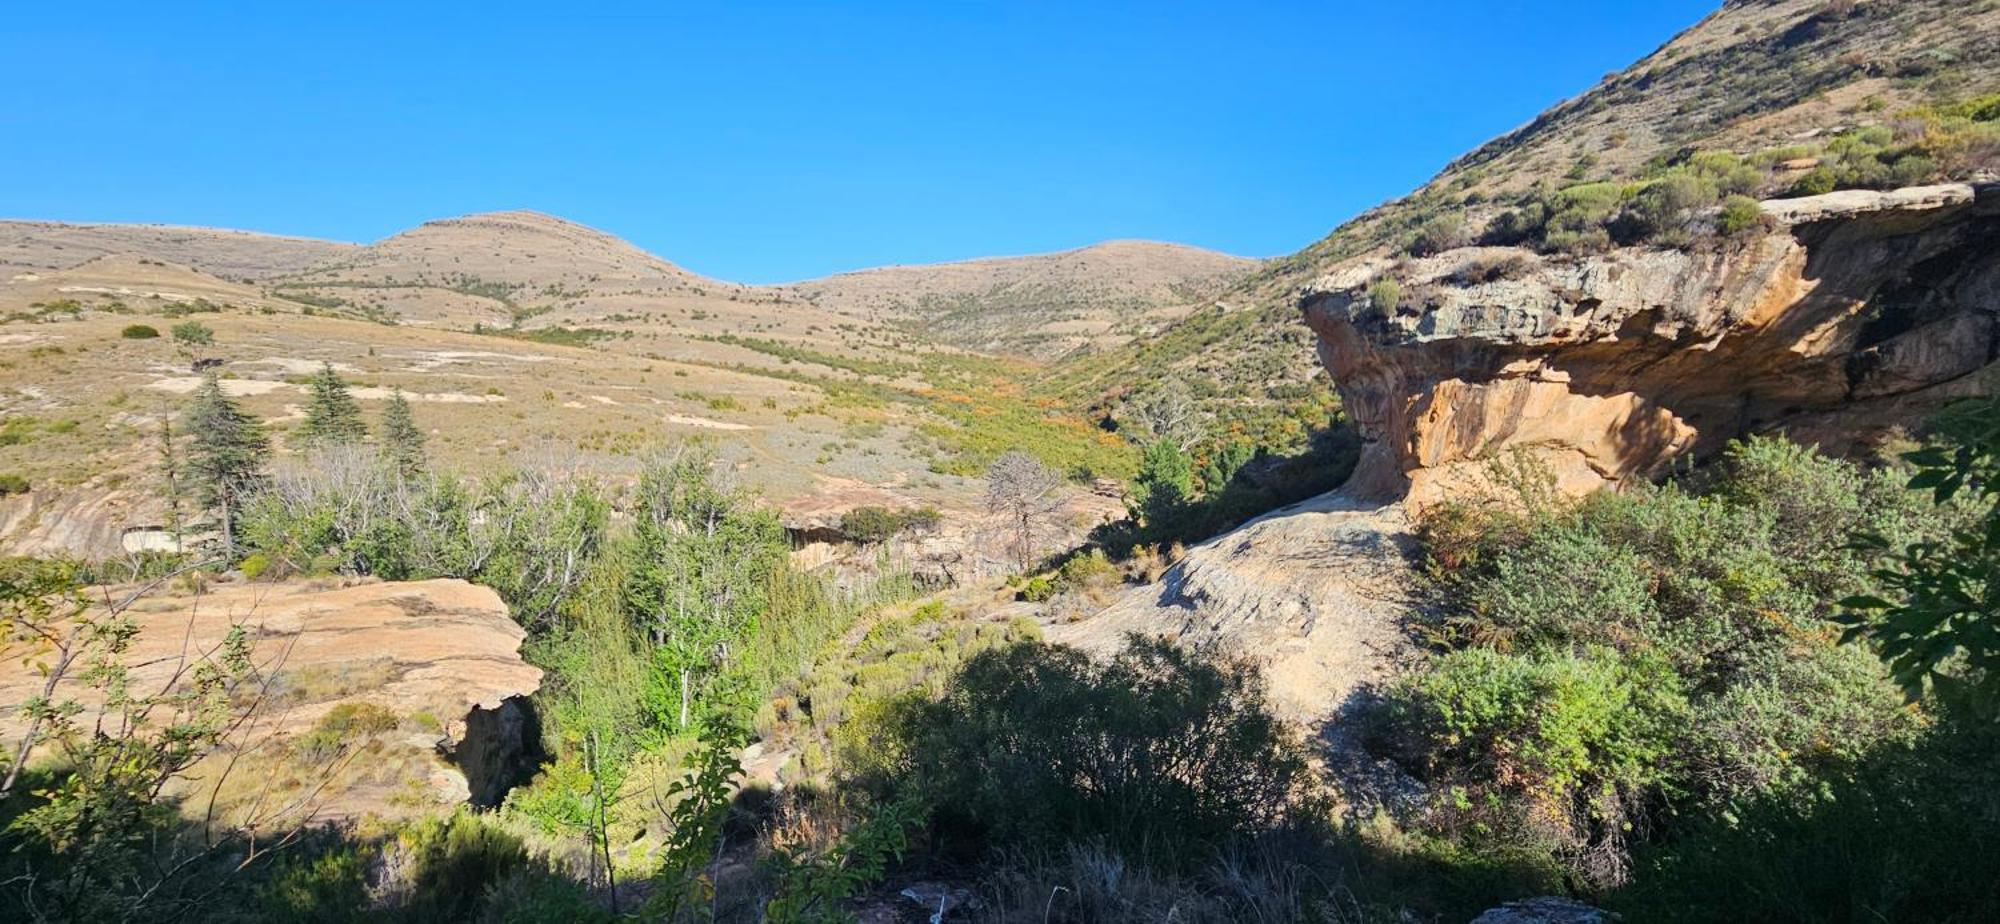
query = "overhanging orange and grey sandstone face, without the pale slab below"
xmin=1300 ymin=184 xmax=2000 ymax=504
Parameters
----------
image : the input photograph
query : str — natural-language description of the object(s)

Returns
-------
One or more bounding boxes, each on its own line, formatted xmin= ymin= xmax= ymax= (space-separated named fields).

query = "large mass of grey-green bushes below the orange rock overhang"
xmin=1388 ymin=440 xmax=1950 ymax=886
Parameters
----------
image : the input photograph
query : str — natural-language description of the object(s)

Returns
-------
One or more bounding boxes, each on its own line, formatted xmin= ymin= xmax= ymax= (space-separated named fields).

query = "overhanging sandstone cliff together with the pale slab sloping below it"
xmin=1050 ymin=184 xmax=2000 ymax=728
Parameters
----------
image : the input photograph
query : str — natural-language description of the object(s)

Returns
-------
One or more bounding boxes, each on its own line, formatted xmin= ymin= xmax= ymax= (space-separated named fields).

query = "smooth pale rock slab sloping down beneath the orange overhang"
xmin=1048 ymin=492 xmax=1410 ymax=724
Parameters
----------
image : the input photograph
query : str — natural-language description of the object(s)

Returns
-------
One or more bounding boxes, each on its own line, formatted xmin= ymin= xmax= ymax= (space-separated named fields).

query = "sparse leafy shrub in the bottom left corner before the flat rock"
xmin=0 ymin=558 xmax=272 ymax=920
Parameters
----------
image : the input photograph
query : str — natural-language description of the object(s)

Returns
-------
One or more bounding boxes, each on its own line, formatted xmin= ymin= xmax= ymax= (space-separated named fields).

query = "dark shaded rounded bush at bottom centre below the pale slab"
xmin=856 ymin=638 xmax=1314 ymax=866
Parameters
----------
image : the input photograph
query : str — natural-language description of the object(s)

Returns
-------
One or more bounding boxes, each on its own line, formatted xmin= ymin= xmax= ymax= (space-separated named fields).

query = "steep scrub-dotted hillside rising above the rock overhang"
xmin=1058 ymin=0 xmax=2000 ymax=430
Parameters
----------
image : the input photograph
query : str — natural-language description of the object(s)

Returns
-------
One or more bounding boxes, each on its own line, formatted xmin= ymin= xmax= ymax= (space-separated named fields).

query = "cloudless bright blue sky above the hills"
xmin=0 ymin=0 xmax=1718 ymax=282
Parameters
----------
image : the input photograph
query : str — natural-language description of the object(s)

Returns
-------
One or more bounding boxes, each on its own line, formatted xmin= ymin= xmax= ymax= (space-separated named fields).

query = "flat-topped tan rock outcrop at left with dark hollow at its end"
xmin=0 ymin=580 xmax=542 ymax=818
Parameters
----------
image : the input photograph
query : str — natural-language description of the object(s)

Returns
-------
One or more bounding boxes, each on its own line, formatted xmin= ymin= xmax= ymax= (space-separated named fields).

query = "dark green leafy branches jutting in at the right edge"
xmin=1842 ymin=398 xmax=2000 ymax=714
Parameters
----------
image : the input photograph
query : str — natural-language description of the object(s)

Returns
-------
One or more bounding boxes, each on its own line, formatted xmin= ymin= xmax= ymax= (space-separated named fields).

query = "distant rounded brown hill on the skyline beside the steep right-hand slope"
xmin=792 ymin=240 xmax=1258 ymax=356
